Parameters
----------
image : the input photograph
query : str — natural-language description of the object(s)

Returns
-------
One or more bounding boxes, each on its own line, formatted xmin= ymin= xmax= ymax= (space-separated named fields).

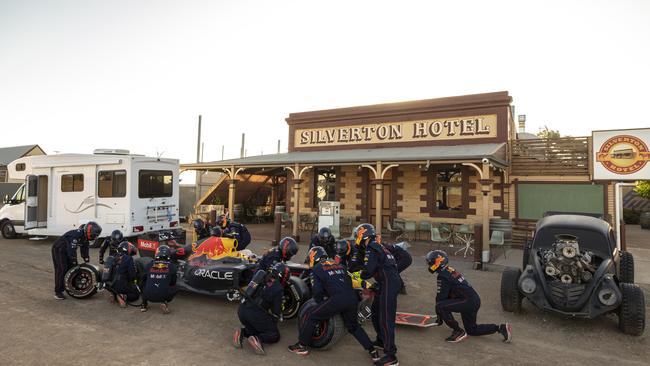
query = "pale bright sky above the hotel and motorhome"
xmin=0 ymin=0 xmax=650 ymax=183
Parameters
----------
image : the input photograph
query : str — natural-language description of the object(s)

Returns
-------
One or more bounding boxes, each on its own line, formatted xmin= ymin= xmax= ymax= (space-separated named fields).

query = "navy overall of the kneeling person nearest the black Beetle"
xmin=436 ymin=266 xmax=499 ymax=336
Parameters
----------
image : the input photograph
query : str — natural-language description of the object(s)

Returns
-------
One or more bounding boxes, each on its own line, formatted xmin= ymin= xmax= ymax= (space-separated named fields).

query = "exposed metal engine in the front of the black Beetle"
xmin=540 ymin=235 xmax=597 ymax=284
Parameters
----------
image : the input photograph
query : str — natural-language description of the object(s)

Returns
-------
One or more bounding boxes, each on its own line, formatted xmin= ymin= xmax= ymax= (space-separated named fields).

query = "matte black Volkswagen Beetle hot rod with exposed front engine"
xmin=501 ymin=214 xmax=645 ymax=336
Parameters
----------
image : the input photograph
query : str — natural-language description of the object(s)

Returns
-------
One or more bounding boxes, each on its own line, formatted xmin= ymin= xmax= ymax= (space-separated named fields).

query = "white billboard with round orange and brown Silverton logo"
xmin=592 ymin=128 xmax=650 ymax=181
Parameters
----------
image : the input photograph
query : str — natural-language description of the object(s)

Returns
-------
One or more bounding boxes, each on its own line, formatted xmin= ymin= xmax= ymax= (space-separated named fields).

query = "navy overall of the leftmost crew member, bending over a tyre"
xmin=52 ymin=229 xmax=90 ymax=293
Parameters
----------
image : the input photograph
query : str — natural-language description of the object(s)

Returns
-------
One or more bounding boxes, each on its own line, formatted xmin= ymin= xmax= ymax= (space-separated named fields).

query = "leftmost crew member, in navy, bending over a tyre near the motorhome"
xmin=52 ymin=221 xmax=102 ymax=300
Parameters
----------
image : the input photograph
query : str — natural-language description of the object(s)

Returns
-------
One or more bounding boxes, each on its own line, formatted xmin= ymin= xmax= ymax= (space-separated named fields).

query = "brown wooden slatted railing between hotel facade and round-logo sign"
xmin=510 ymin=137 xmax=590 ymax=176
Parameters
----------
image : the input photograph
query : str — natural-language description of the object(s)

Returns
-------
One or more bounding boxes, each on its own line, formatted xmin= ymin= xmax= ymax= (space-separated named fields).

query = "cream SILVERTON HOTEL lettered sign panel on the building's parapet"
xmin=294 ymin=114 xmax=497 ymax=148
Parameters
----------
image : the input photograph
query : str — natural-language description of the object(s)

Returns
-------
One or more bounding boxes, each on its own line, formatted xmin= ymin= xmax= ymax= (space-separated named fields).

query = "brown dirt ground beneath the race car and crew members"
xmin=0 ymin=234 xmax=650 ymax=366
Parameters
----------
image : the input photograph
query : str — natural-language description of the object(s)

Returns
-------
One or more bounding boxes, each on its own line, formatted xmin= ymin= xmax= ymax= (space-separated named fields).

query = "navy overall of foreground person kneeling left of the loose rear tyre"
xmin=237 ymin=280 xmax=284 ymax=343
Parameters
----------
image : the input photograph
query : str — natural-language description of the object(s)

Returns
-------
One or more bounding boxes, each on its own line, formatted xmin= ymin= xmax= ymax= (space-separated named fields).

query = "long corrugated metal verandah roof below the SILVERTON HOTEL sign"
xmin=181 ymin=143 xmax=506 ymax=169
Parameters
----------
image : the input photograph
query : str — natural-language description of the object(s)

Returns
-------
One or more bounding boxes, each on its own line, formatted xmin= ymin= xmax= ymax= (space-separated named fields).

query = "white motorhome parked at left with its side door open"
xmin=0 ymin=149 xmax=179 ymax=243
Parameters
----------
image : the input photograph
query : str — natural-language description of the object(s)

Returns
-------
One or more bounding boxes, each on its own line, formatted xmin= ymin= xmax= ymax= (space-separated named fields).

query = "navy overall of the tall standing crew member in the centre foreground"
xmin=361 ymin=241 xmax=402 ymax=356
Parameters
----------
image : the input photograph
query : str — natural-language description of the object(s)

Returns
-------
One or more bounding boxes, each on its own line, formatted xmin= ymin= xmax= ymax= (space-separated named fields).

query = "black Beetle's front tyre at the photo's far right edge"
xmin=618 ymin=283 xmax=645 ymax=336
